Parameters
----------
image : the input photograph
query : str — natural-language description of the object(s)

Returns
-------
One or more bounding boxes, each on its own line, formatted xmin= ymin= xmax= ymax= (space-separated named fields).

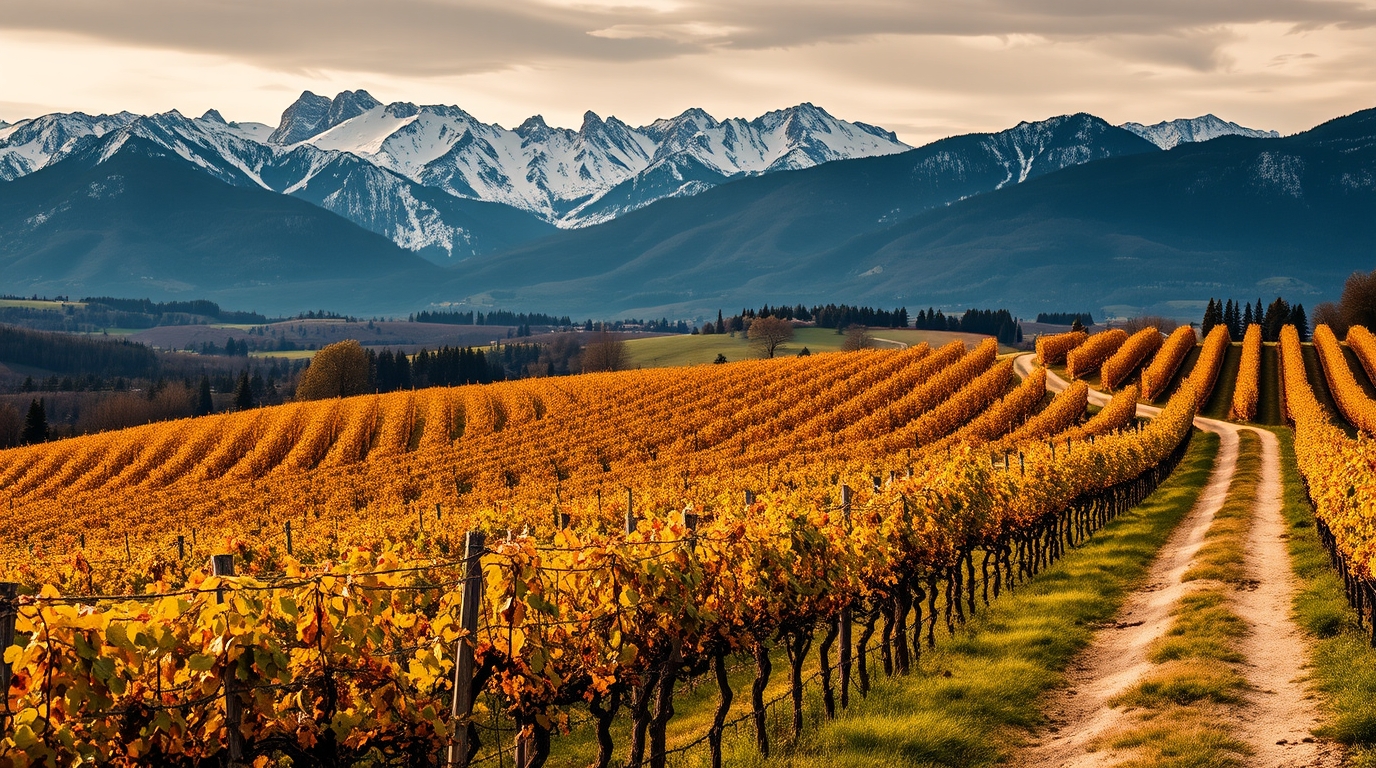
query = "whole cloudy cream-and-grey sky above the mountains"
xmin=0 ymin=0 xmax=1376 ymax=143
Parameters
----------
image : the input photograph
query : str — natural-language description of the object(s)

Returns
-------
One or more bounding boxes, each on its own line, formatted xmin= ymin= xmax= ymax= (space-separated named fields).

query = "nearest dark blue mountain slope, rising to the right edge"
xmin=776 ymin=110 xmax=1376 ymax=315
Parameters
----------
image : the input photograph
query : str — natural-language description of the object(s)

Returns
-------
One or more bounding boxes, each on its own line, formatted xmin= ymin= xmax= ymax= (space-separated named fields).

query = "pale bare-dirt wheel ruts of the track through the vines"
xmin=1013 ymin=355 xmax=1343 ymax=768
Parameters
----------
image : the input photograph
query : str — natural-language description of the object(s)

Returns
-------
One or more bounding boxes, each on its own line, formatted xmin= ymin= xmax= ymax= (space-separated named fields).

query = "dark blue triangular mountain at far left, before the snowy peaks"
xmin=0 ymin=136 xmax=440 ymax=312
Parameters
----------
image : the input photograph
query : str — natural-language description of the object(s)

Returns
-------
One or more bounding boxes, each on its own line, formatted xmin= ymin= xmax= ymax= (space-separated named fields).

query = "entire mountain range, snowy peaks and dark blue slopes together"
xmin=0 ymin=91 xmax=1376 ymax=322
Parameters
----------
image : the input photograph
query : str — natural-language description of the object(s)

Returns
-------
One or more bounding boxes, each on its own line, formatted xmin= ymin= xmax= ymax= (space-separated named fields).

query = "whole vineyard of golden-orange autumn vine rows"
xmin=0 ymin=317 xmax=1376 ymax=767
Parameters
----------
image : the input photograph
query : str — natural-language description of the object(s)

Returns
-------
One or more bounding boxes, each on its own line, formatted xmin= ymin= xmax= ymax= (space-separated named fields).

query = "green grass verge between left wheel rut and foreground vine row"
xmin=727 ymin=435 xmax=1218 ymax=768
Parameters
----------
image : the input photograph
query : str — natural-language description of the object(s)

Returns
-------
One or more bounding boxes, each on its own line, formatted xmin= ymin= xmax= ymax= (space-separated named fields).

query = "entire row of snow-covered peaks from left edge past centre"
xmin=0 ymin=91 xmax=908 ymax=263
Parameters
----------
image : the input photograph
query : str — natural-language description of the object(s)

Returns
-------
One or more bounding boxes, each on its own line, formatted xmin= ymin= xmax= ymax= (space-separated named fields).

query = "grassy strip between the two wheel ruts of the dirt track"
xmin=1105 ymin=431 xmax=1262 ymax=768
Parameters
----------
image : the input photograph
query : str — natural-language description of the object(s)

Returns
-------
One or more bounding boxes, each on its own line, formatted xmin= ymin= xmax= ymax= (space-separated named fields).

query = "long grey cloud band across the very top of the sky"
xmin=0 ymin=0 xmax=1376 ymax=77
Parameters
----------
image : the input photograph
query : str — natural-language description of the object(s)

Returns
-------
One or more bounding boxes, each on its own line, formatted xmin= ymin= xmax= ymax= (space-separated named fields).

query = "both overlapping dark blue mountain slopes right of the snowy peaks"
xmin=434 ymin=110 xmax=1376 ymax=317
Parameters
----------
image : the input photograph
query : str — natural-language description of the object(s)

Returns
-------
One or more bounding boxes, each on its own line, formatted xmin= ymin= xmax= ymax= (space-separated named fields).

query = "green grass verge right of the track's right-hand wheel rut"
xmin=1273 ymin=429 xmax=1376 ymax=768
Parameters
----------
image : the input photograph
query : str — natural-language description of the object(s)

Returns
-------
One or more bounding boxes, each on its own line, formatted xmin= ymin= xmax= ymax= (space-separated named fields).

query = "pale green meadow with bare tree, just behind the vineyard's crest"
xmin=626 ymin=328 xmax=1013 ymax=367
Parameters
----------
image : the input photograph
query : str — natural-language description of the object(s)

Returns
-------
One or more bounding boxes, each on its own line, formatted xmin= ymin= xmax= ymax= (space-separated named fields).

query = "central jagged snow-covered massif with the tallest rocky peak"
xmin=286 ymin=91 xmax=911 ymax=227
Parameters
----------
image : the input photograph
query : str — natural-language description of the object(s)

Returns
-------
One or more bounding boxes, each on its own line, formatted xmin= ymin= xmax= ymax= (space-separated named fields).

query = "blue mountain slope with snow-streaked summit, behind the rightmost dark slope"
xmin=453 ymin=114 xmax=1159 ymax=314
